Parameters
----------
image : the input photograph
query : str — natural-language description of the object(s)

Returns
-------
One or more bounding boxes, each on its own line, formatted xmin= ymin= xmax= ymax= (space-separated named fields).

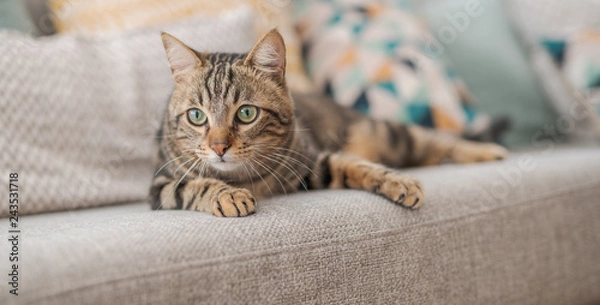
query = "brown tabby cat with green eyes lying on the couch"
xmin=150 ymin=29 xmax=507 ymax=217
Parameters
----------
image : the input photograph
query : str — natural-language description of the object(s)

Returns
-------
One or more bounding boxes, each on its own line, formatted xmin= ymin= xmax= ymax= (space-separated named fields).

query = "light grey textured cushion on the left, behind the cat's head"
xmin=0 ymin=8 xmax=254 ymax=216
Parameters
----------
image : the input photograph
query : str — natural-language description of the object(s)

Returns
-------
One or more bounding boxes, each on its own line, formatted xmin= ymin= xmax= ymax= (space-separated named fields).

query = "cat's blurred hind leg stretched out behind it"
xmin=343 ymin=119 xmax=508 ymax=167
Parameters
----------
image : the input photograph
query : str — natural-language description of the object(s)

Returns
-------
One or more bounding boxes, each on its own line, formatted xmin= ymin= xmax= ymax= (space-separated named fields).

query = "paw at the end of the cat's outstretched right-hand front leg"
xmin=373 ymin=171 xmax=425 ymax=209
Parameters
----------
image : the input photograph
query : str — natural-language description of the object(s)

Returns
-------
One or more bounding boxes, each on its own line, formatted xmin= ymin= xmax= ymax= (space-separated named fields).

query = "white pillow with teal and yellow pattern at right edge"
xmin=507 ymin=0 xmax=600 ymax=142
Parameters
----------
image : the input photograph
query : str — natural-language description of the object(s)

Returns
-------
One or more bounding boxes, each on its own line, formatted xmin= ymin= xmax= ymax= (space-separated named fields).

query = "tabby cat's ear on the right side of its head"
xmin=244 ymin=29 xmax=285 ymax=83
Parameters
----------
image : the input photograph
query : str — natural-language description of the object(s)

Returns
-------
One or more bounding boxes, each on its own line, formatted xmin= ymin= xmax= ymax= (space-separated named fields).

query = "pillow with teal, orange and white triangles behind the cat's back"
xmin=296 ymin=0 xmax=490 ymax=134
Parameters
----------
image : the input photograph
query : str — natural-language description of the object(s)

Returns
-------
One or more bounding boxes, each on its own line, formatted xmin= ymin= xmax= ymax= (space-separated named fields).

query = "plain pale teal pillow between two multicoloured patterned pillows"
xmin=424 ymin=0 xmax=557 ymax=148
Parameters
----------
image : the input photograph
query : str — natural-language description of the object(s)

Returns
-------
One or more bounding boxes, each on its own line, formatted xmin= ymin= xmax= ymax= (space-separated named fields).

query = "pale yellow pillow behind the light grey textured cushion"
xmin=50 ymin=0 xmax=311 ymax=92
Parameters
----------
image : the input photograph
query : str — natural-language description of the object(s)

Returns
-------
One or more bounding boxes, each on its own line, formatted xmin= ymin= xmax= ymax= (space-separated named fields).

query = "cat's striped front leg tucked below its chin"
xmin=150 ymin=176 xmax=256 ymax=217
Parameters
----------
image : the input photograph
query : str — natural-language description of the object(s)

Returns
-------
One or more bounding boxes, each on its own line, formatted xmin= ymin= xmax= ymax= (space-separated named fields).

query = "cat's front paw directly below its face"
xmin=212 ymin=188 xmax=256 ymax=217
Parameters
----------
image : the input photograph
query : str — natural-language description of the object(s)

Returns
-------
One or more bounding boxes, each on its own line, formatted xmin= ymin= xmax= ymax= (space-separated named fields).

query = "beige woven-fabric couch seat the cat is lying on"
xmin=8 ymin=148 xmax=600 ymax=304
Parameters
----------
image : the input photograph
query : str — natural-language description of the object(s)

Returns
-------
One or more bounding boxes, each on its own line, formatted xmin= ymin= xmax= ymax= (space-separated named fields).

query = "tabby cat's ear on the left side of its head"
xmin=161 ymin=32 xmax=202 ymax=80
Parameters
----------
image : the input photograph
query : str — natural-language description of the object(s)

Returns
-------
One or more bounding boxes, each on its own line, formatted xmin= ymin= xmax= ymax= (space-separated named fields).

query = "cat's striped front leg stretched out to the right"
xmin=310 ymin=152 xmax=424 ymax=209
